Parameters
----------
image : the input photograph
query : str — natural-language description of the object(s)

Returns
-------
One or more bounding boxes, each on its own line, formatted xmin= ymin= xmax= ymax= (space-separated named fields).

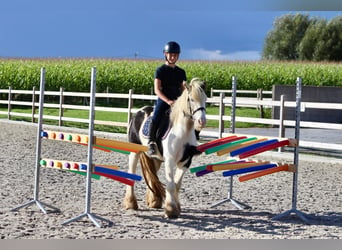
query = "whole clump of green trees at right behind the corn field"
xmin=262 ymin=14 xmax=342 ymax=61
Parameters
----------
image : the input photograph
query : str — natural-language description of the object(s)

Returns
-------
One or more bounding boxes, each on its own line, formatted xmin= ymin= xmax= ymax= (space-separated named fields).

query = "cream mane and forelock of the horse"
xmin=170 ymin=78 xmax=206 ymax=123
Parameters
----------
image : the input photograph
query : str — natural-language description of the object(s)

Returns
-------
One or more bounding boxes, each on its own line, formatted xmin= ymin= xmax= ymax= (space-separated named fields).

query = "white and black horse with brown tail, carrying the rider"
xmin=123 ymin=78 xmax=207 ymax=219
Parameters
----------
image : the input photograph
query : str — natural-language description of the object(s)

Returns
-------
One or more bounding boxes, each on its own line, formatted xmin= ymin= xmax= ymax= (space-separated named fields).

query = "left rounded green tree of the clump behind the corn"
xmin=262 ymin=14 xmax=312 ymax=60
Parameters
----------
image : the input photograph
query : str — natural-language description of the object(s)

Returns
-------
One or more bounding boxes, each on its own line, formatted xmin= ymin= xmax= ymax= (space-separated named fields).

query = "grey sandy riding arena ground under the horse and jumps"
xmin=0 ymin=120 xmax=342 ymax=239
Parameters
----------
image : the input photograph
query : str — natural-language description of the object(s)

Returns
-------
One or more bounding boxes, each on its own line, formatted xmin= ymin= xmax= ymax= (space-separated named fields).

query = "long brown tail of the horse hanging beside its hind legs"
xmin=140 ymin=153 xmax=165 ymax=199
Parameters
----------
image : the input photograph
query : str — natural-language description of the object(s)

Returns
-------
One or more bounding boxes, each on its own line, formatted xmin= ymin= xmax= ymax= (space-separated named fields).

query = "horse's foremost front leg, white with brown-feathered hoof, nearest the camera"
xmin=165 ymin=159 xmax=180 ymax=218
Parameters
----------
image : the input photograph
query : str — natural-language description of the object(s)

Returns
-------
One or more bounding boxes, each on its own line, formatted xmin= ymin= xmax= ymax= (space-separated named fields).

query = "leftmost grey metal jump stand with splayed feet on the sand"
xmin=11 ymin=68 xmax=60 ymax=214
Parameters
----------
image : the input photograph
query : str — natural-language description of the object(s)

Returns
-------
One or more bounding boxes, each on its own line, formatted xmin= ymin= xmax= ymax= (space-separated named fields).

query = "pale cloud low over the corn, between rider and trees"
xmin=187 ymin=49 xmax=261 ymax=61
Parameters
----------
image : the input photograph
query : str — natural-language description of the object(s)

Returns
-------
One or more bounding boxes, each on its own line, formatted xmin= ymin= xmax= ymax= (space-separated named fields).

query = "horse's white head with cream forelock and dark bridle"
xmin=186 ymin=78 xmax=207 ymax=132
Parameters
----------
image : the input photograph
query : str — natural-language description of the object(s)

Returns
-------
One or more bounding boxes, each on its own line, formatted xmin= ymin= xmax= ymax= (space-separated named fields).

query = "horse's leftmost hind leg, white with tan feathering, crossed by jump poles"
xmin=123 ymin=152 xmax=140 ymax=210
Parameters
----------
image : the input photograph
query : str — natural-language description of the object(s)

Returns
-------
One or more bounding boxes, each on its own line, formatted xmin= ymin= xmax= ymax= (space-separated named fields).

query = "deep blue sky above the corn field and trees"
xmin=0 ymin=0 xmax=342 ymax=61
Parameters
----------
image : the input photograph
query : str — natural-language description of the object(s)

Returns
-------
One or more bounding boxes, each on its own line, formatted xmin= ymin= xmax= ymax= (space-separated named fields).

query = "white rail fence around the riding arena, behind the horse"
xmin=0 ymin=88 xmax=342 ymax=154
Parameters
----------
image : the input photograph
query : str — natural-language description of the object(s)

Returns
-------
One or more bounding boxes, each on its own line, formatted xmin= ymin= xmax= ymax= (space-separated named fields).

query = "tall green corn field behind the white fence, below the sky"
xmin=0 ymin=59 xmax=342 ymax=94
